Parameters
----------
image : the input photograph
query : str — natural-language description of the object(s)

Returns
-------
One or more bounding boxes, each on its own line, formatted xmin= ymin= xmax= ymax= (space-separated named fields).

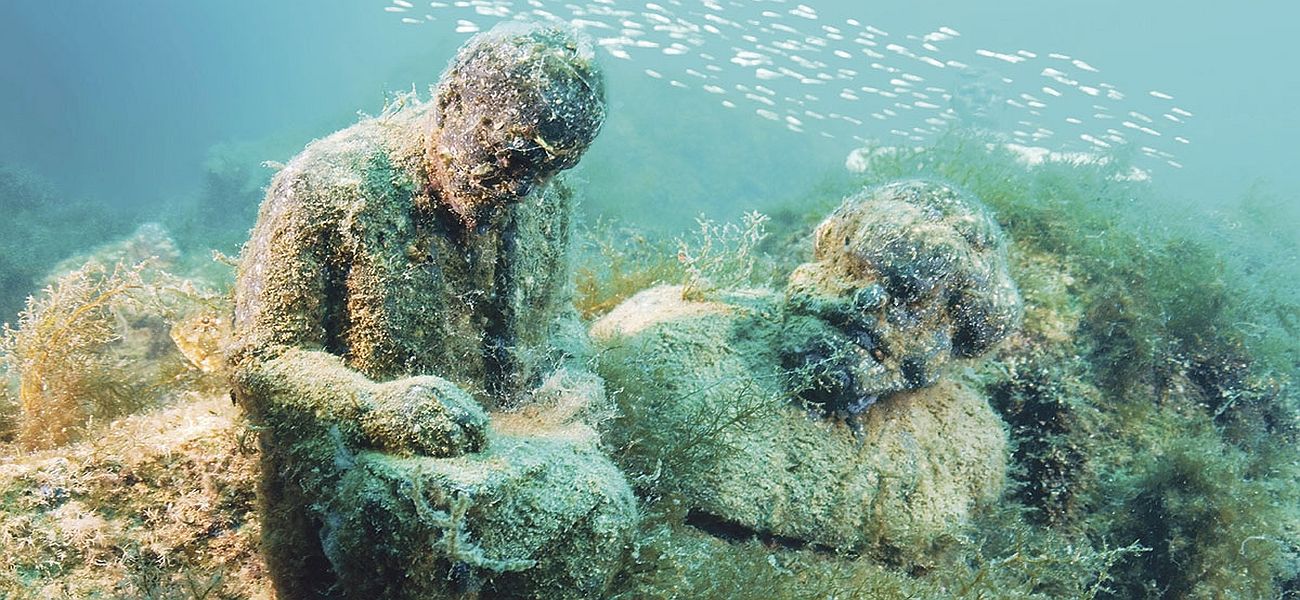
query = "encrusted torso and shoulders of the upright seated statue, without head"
xmin=239 ymin=106 xmax=571 ymax=404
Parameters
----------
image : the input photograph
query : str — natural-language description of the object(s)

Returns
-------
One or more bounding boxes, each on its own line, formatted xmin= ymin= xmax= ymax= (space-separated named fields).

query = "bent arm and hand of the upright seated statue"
xmin=230 ymin=168 xmax=488 ymax=456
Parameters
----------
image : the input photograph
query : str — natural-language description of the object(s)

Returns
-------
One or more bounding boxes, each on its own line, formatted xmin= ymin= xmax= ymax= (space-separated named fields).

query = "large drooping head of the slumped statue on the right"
xmin=783 ymin=181 xmax=1022 ymax=413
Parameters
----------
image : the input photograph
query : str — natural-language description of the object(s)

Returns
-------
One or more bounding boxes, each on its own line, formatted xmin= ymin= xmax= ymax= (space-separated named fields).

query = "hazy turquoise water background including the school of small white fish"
xmin=0 ymin=0 xmax=1300 ymax=236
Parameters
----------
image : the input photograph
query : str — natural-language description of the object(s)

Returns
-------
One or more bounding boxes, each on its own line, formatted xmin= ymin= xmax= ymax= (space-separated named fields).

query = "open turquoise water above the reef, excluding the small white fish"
xmin=0 ymin=0 xmax=1300 ymax=229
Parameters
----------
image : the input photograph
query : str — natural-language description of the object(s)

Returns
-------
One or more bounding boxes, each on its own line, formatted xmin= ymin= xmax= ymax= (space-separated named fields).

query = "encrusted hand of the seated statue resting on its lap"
xmin=361 ymin=377 xmax=488 ymax=457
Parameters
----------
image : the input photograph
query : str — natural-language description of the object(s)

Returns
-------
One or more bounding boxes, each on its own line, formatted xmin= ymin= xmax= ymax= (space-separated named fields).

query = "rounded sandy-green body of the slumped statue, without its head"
xmin=593 ymin=287 xmax=1006 ymax=564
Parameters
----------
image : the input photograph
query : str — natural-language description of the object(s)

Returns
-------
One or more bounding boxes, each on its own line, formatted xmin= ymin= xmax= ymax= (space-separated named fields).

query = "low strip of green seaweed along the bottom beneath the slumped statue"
xmin=611 ymin=503 xmax=1149 ymax=600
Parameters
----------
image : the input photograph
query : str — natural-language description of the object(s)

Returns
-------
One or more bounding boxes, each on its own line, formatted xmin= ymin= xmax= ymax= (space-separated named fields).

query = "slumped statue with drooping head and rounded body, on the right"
xmin=592 ymin=181 xmax=1022 ymax=564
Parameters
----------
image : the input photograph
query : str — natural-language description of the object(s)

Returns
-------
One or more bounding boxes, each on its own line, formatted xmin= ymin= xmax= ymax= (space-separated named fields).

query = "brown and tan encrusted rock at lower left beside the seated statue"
xmin=0 ymin=395 xmax=272 ymax=600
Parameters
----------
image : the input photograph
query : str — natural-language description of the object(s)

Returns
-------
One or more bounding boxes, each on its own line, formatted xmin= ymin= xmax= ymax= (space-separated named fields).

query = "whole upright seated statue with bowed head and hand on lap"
xmin=230 ymin=25 xmax=636 ymax=599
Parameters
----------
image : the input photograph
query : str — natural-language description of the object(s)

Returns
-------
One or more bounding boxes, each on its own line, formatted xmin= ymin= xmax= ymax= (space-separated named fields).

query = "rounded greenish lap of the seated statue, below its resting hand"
xmin=322 ymin=426 xmax=638 ymax=599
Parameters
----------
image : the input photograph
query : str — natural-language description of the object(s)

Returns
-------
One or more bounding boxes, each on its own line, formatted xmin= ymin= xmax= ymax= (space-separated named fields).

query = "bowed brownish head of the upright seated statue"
xmin=429 ymin=22 xmax=605 ymax=222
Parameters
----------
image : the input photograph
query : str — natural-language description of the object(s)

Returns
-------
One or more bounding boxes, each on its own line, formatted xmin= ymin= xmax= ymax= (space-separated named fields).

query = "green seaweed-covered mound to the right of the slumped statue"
xmin=780 ymin=135 xmax=1300 ymax=597
